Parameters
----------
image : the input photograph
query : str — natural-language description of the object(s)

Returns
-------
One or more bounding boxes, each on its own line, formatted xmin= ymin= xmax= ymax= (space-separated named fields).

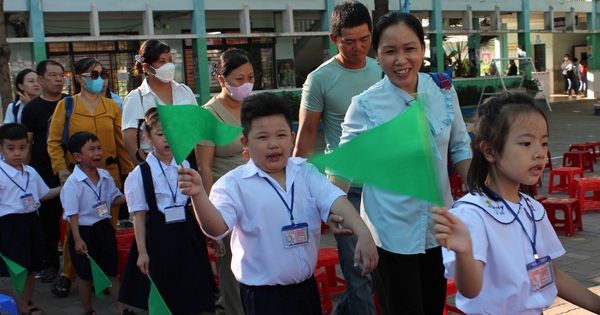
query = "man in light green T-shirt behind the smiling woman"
xmin=294 ymin=2 xmax=381 ymax=314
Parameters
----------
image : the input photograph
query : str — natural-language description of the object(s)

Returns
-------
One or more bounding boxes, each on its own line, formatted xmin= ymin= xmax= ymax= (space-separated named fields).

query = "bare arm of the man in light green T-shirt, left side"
xmin=293 ymin=107 xmax=321 ymax=158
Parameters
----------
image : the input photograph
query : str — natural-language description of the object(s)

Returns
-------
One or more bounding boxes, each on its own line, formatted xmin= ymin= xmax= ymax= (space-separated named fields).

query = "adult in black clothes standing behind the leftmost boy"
xmin=21 ymin=60 xmax=67 ymax=283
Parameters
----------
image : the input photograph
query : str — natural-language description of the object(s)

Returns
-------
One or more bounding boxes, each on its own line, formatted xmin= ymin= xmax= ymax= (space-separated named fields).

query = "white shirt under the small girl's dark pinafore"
xmin=125 ymin=151 xmax=195 ymax=214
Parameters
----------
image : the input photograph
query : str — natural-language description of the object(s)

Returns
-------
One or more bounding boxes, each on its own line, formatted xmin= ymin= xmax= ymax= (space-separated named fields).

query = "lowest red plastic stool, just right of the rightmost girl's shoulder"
xmin=542 ymin=198 xmax=583 ymax=236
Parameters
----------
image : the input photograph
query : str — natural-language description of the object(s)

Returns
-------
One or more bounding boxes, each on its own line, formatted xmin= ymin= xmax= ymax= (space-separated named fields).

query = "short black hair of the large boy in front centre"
xmin=240 ymin=92 xmax=292 ymax=138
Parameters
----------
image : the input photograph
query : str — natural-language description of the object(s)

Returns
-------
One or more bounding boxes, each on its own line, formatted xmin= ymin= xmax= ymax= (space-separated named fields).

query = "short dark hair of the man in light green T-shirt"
xmin=331 ymin=1 xmax=373 ymax=37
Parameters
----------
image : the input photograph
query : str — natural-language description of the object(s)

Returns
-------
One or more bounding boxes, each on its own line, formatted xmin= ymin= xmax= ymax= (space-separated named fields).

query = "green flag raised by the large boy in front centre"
xmin=156 ymin=104 xmax=242 ymax=164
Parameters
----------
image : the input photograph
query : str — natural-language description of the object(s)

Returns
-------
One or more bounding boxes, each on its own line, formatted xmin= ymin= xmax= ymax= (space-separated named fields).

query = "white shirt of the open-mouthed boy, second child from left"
xmin=60 ymin=164 xmax=123 ymax=226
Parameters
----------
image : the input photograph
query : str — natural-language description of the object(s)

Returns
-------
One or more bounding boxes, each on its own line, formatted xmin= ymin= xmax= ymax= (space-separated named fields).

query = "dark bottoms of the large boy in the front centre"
xmin=240 ymin=276 xmax=322 ymax=315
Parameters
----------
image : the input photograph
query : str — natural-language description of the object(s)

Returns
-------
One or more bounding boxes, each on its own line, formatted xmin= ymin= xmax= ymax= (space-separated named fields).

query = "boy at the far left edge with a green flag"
xmin=0 ymin=123 xmax=61 ymax=315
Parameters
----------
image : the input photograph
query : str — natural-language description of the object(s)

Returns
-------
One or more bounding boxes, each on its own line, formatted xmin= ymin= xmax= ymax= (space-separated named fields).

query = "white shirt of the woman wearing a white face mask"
xmin=121 ymin=80 xmax=198 ymax=152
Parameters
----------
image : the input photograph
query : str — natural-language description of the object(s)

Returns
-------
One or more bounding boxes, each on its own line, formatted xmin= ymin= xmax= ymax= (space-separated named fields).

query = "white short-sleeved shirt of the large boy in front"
xmin=205 ymin=158 xmax=345 ymax=286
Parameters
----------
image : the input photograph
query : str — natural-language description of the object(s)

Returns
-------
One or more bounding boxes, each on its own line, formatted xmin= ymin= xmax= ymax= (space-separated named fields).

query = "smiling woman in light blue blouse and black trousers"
xmin=335 ymin=12 xmax=472 ymax=314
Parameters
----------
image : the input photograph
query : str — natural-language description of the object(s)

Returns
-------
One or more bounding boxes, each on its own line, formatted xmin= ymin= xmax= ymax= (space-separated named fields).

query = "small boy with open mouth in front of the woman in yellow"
xmin=60 ymin=131 xmax=134 ymax=315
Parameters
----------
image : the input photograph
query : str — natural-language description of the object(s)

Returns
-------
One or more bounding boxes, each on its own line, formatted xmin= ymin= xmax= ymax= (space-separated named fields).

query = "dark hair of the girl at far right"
xmin=465 ymin=92 xmax=548 ymax=201
